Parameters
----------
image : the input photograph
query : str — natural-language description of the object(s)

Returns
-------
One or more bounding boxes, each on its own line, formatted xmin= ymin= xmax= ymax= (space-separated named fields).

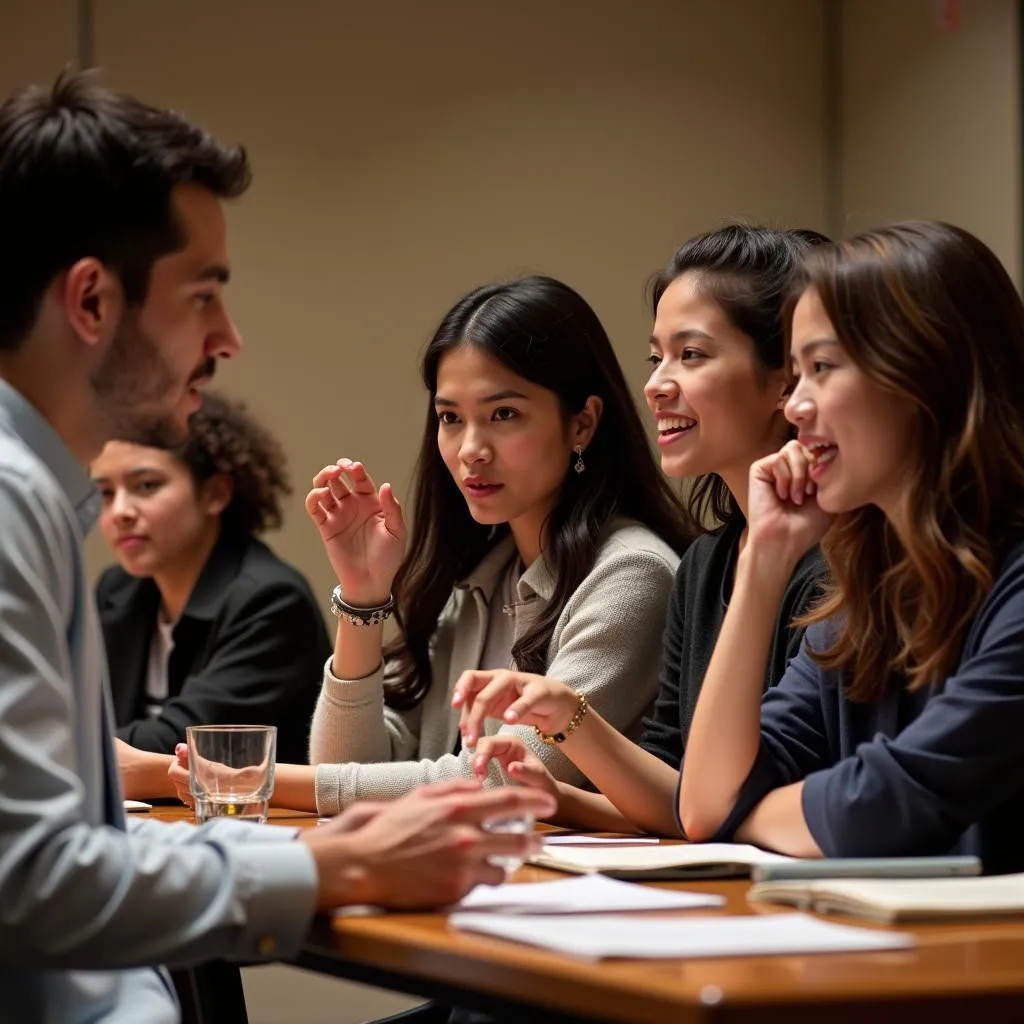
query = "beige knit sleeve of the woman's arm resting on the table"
xmin=315 ymin=550 xmax=675 ymax=814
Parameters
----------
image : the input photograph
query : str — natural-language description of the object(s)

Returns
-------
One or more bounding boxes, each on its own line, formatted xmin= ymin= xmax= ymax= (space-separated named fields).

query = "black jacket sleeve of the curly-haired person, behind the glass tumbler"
xmin=117 ymin=581 xmax=330 ymax=754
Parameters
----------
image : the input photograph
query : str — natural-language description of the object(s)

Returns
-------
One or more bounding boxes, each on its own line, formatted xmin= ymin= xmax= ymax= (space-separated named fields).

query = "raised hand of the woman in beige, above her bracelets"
xmin=306 ymin=459 xmax=406 ymax=607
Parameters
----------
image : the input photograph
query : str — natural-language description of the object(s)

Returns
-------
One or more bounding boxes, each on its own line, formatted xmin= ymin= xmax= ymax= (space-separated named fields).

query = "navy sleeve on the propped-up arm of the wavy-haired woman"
xmin=712 ymin=628 xmax=833 ymax=843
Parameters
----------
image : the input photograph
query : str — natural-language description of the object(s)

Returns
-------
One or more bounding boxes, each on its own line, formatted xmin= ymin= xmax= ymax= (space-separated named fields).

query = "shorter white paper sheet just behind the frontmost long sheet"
xmin=452 ymin=874 xmax=725 ymax=914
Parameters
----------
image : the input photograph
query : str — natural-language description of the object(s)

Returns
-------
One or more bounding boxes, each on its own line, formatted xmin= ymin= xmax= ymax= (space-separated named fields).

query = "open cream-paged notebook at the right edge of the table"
xmin=746 ymin=874 xmax=1024 ymax=924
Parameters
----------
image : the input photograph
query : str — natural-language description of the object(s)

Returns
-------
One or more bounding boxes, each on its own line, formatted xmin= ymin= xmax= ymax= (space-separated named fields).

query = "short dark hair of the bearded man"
xmin=0 ymin=72 xmax=250 ymax=351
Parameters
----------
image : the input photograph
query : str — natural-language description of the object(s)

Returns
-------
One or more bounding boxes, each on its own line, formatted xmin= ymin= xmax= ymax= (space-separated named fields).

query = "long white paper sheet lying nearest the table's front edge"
xmin=449 ymin=913 xmax=914 ymax=959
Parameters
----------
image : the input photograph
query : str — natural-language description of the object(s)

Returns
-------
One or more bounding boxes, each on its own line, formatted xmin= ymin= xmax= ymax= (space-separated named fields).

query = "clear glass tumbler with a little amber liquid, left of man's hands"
xmin=185 ymin=725 xmax=278 ymax=824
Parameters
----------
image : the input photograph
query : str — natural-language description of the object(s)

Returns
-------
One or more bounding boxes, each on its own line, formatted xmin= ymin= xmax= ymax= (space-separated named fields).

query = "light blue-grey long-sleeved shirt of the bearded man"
xmin=0 ymin=380 xmax=316 ymax=1024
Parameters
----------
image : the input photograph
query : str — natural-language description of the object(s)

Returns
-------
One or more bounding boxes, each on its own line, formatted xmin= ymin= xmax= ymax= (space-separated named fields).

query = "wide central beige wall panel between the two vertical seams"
xmin=81 ymin=0 xmax=823 ymax=594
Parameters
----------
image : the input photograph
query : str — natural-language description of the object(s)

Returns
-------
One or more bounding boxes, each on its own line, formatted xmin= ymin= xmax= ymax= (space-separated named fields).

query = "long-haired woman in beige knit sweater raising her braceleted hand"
xmin=169 ymin=276 xmax=692 ymax=814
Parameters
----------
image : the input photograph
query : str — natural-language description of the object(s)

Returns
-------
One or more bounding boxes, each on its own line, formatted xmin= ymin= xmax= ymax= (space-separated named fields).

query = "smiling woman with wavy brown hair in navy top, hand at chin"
xmin=679 ymin=221 xmax=1024 ymax=873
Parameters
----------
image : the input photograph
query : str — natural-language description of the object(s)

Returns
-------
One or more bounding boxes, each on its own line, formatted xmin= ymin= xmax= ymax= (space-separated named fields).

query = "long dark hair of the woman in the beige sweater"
xmin=385 ymin=276 xmax=696 ymax=709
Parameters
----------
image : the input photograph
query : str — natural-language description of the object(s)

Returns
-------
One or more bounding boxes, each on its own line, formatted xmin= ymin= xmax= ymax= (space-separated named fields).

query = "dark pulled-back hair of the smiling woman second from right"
xmin=648 ymin=224 xmax=828 ymax=522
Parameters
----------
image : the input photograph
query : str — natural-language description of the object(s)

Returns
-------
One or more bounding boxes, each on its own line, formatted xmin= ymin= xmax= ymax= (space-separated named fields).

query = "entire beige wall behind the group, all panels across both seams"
xmin=0 ymin=0 xmax=1020 ymax=1024
